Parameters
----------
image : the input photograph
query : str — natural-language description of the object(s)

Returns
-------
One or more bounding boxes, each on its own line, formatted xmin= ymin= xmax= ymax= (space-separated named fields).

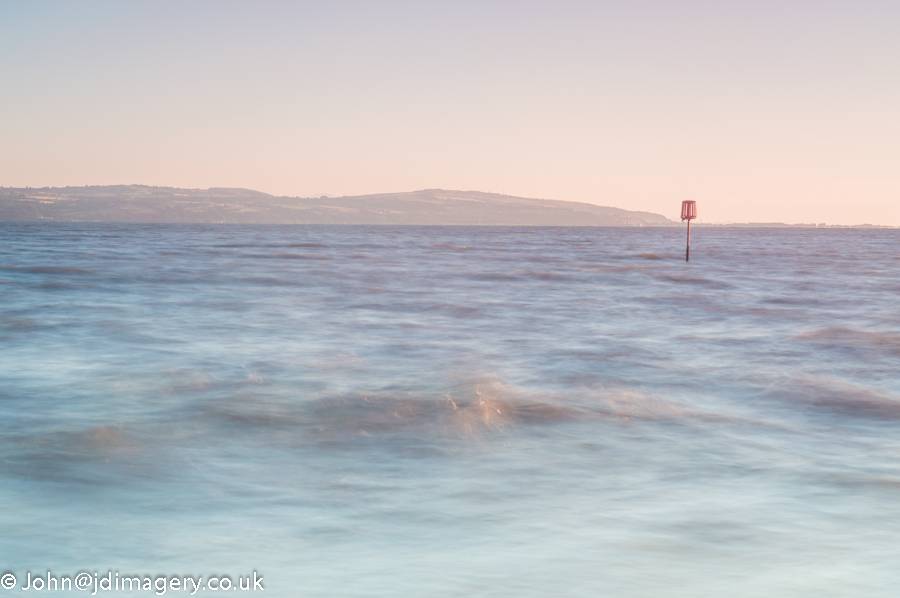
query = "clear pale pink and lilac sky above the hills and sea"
xmin=0 ymin=0 xmax=900 ymax=226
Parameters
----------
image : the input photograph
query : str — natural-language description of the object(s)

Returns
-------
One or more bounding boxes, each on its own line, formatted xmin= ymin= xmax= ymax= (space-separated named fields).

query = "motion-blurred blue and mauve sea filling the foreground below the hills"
xmin=0 ymin=224 xmax=900 ymax=598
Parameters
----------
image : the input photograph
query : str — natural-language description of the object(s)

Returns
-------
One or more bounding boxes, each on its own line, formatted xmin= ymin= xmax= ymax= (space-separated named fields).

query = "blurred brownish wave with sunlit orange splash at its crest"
xmin=198 ymin=378 xmax=746 ymax=448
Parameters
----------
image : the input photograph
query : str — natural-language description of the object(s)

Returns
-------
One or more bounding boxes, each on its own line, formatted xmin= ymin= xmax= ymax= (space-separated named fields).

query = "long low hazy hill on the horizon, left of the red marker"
xmin=0 ymin=185 xmax=673 ymax=226
